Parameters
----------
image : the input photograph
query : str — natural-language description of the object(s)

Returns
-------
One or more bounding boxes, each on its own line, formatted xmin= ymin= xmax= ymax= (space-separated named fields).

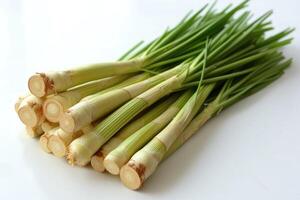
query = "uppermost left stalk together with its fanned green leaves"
xmin=28 ymin=1 xmax=239 ymax=97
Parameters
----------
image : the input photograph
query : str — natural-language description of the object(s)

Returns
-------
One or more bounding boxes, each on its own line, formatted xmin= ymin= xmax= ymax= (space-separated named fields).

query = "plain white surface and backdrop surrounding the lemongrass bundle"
xmin=0 ymin=0 xmax=300 ymax=200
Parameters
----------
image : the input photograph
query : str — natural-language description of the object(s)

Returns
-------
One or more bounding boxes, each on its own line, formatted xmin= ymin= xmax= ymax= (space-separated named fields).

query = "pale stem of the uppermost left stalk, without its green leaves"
xmin=28 ymin=59 xmax=144 ymax=97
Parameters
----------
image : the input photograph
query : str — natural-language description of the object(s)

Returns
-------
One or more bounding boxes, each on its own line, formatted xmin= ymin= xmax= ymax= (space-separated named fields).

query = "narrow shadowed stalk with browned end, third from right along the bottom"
xmin=91 ymin=96 xmax=176 ymax=172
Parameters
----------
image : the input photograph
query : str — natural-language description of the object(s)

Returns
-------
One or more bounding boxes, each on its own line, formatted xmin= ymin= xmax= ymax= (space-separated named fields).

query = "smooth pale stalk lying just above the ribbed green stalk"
xmin=59 ymin=65 xmax=183 ymax=134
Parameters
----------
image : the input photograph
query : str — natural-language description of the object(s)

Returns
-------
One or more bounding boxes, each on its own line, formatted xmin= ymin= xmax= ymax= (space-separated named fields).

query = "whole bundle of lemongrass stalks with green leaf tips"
xmin=15 ymin=1 xmax=292 ymax=189
